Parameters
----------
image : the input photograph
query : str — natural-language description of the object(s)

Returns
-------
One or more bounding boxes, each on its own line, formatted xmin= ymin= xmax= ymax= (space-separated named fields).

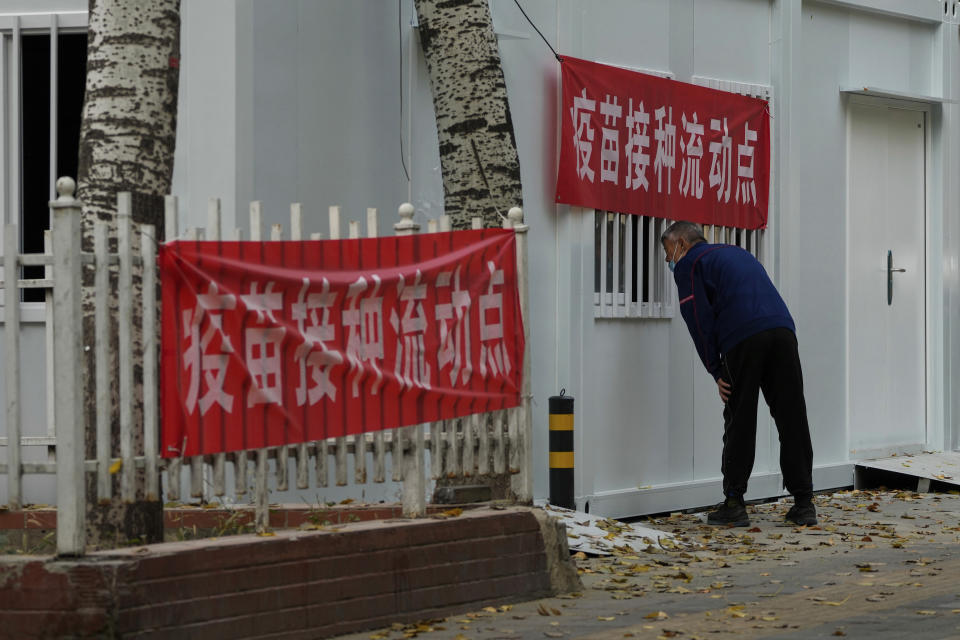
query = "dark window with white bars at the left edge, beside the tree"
xmin=0 ymin=12 xmax=87 ymax=302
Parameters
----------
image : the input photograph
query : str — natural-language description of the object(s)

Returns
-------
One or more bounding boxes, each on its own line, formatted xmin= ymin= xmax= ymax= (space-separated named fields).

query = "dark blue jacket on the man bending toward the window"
xmin=673 ymin=242 xmax=796 ymax=379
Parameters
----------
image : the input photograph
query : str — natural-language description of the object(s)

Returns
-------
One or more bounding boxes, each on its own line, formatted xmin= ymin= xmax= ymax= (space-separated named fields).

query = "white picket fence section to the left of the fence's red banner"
xmin=0 ymin=178 xmax=159 ymax=555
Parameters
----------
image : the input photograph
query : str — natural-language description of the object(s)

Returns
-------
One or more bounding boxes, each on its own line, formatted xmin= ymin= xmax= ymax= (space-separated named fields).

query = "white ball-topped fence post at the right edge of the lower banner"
xmin=507 ymin=207 xmax=533 ymax=504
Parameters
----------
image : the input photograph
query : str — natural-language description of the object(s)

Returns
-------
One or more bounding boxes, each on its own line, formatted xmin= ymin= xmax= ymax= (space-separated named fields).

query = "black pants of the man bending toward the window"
xmin=721 ymin=328 xmax=813 ymax=498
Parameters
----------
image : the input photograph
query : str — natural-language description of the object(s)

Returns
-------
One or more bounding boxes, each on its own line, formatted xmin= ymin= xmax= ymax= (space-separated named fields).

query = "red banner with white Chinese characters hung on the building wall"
xmin=557 ymin=57 xmax=770 ymax=229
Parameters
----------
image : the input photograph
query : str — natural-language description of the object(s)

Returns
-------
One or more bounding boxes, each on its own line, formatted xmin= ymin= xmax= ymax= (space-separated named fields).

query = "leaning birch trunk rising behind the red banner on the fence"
xmin=414 ymin=0 xmax=523 ymax=229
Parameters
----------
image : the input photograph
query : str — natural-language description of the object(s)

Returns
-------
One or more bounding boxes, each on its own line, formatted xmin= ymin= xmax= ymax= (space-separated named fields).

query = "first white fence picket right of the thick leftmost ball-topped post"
xmin=93 ymin=220 xmax=113 ymax=500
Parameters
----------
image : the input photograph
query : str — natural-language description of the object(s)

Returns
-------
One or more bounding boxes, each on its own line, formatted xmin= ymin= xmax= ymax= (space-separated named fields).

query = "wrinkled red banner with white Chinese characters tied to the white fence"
xmin=160 ymin=229 xmax=524 ymax=457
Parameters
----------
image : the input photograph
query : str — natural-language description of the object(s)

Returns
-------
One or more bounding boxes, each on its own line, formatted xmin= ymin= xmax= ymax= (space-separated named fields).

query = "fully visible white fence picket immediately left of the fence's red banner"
xmin=140 ymin=224 xmax=160 ymax=502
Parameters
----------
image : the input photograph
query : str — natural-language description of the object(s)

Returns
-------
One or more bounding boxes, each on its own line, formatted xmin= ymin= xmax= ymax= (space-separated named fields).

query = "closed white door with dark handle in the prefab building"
xmin=847 ymin=104 xmax=926 ymax=452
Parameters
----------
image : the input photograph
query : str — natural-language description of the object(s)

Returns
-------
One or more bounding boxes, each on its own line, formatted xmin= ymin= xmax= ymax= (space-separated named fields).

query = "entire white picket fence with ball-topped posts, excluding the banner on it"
xmin=0 ymin=179 xmax=533 ymax=555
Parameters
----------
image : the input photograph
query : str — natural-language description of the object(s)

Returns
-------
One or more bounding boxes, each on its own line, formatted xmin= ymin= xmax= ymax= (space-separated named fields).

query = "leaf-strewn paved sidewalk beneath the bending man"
xmin=344 ymin=491 xmax=960 ymax=640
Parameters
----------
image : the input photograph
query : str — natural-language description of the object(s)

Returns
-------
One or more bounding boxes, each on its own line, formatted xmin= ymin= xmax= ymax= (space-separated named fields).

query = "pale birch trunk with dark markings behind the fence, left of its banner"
xmin=77 ymin=0 xmax=180 ymax=547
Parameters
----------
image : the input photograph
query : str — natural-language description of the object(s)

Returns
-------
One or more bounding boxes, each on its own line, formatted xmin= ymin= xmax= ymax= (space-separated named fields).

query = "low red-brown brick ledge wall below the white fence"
xmin=0 ymin=507 xmax=565 ymax=639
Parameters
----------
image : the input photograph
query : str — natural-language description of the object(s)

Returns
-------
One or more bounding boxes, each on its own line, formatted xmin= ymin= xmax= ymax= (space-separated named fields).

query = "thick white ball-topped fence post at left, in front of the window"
xmin=50 ymin=178 xmax=87 ymax=556
